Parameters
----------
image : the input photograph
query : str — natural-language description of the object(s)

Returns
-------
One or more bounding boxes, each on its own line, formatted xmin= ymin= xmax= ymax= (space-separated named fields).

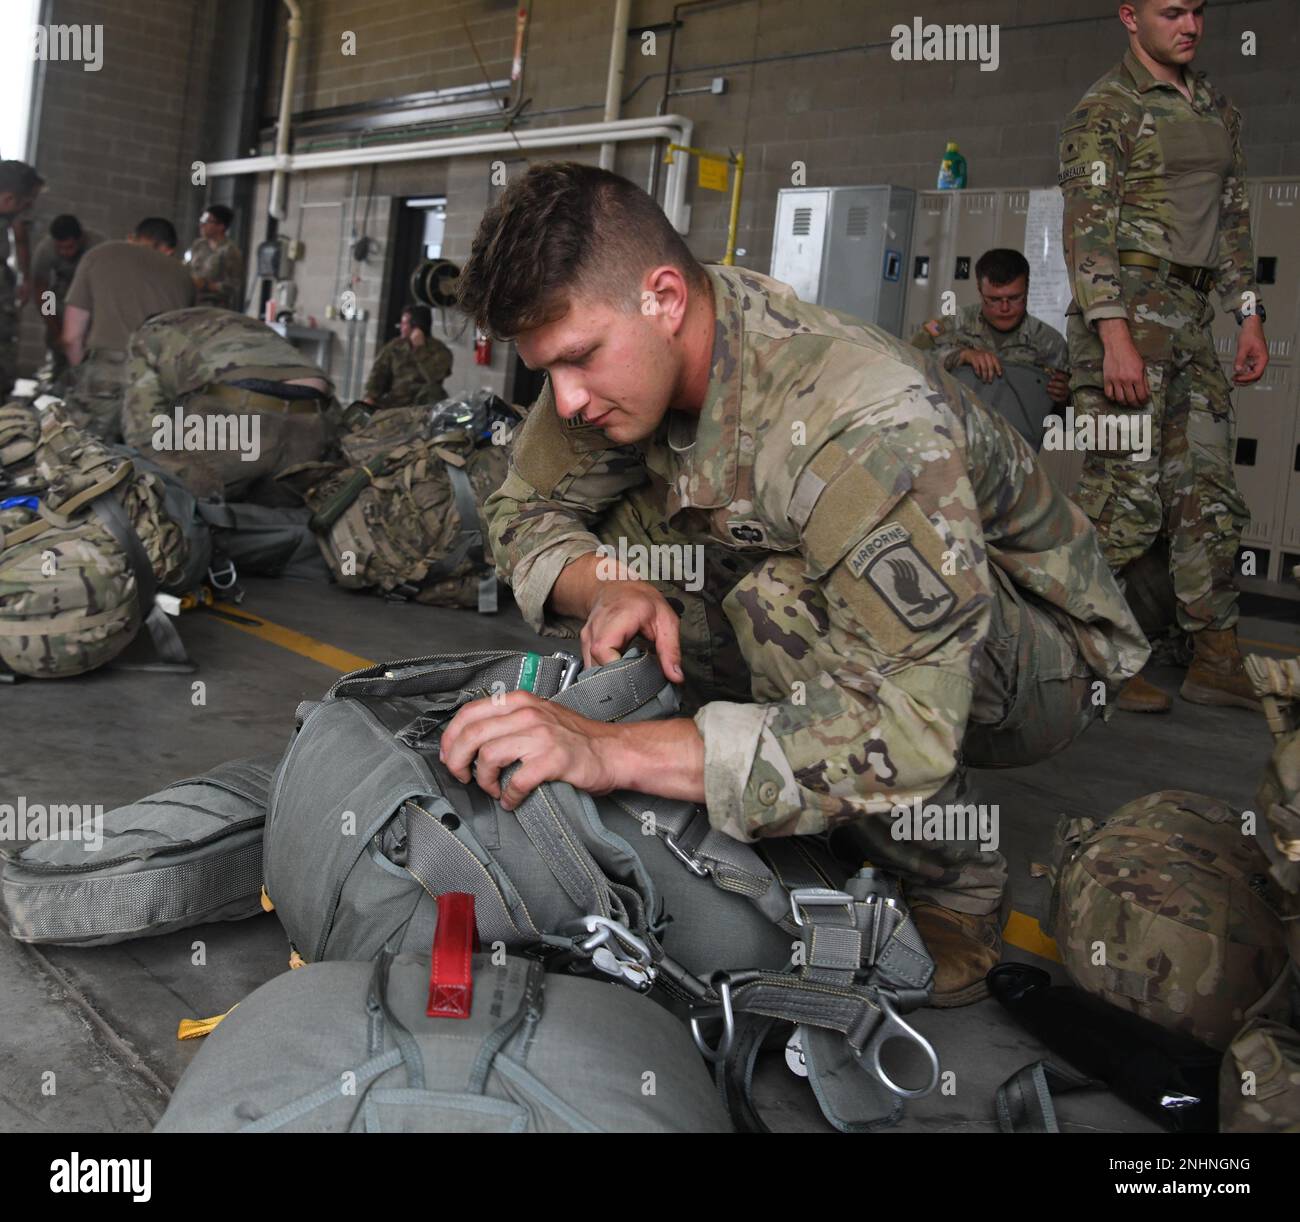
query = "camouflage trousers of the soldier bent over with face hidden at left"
xmin=122 ymin=387 xmax=330 ymax=506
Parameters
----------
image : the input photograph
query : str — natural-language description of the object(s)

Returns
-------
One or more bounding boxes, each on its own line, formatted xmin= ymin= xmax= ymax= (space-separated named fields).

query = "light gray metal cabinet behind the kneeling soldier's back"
xmin=772 ymin=187 xmax=915 ymax=335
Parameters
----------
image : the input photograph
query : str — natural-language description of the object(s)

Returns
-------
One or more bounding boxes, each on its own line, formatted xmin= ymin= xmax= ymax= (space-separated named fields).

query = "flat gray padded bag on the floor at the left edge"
xmin=3 ymin=755 xmax=280 ymax=946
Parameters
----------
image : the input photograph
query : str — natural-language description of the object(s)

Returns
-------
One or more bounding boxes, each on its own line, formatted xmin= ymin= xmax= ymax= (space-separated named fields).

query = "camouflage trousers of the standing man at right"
xmin=1069 ymin=268 xmax=1251 ymax=632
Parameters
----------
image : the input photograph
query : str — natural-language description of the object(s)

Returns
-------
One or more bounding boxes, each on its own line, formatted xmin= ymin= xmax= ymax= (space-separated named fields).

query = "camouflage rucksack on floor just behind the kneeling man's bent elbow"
xmin=282 ymin=408 xmax=510 ymax=611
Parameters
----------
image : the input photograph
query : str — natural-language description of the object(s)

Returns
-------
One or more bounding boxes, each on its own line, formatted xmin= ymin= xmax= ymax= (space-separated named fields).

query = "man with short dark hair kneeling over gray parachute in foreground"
xmin=442 ymin=164 xmax=1147 ymax=1005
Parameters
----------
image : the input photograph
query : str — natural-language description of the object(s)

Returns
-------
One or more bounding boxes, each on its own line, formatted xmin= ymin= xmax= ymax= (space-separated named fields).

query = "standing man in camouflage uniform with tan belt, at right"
xmin=1061 ymin=0 xmax=1269 ymax=712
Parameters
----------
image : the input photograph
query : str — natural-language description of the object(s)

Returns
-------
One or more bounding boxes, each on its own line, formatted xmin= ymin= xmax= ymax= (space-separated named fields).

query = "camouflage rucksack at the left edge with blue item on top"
xmin=0 ymin=407 xmax=200 ymax=679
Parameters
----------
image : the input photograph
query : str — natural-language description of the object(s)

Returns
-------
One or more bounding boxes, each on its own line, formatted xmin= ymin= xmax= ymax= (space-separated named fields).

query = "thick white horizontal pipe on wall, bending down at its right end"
xmin=208 ymin=114 xmax=696 ymax=234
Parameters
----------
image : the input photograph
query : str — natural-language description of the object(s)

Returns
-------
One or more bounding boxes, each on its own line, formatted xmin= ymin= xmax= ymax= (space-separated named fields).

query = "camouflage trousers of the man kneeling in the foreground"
xmin=595 ymin=486 xmax=1099 ymax=913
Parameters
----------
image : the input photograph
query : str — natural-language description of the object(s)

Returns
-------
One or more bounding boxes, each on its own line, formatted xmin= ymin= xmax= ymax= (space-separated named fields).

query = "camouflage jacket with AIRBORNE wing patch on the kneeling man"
xmin=485 ymin=268 xmax=1147 ymax=839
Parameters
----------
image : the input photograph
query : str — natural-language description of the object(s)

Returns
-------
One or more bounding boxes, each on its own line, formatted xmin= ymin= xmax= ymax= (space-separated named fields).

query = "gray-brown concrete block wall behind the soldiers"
xmin=12 ymin=0 xmax=1300 ymax=390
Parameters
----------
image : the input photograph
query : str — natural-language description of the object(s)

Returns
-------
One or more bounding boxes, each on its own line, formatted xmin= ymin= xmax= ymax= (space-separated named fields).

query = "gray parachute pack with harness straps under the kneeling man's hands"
xmin=264 ymin=650 xmax=939 ymax=1131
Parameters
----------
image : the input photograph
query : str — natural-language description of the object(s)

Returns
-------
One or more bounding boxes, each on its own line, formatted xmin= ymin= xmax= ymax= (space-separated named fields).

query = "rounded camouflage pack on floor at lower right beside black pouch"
xmin=1052 ymin=790 xmax=1290 ymax=1049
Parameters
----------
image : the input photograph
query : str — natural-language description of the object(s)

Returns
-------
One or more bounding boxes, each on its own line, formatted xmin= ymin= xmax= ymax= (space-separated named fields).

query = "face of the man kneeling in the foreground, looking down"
xmin=516 ymin=287 xmax=681 ymax=445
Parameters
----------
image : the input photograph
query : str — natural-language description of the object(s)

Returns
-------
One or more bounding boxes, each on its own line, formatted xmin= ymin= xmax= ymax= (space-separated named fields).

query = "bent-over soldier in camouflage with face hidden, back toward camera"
xmin=122 ymin=306 xmax=337 ymax=506
